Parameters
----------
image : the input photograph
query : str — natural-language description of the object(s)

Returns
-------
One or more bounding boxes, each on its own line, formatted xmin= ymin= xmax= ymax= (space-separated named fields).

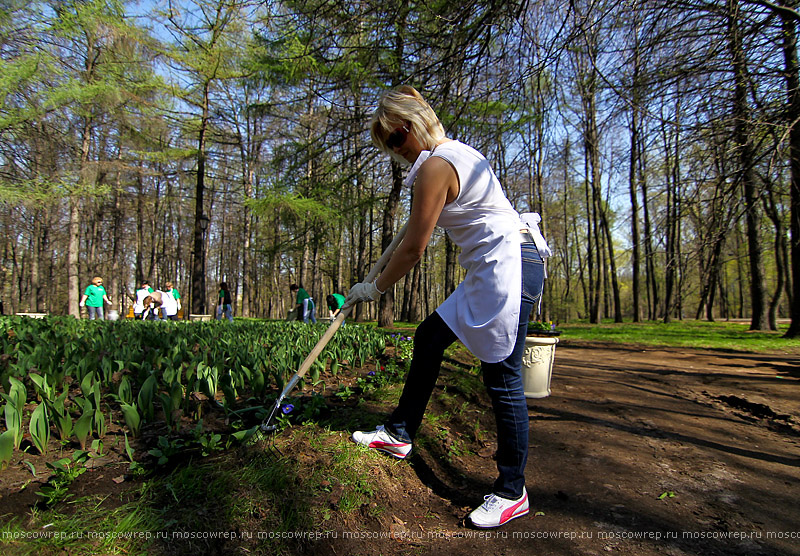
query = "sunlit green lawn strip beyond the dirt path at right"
xmin=558 ymin=320 xmax=800 ymax=353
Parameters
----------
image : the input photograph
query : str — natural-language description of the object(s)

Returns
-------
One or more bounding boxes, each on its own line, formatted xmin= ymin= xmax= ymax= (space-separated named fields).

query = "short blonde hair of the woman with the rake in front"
xmin=370 ymin=85 xmax=444 ymax=155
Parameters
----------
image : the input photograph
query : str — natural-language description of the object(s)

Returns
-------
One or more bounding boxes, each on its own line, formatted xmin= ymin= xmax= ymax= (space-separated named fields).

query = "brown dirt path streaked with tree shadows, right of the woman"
xmin=330 ymin=341 xmax=800 ymax=556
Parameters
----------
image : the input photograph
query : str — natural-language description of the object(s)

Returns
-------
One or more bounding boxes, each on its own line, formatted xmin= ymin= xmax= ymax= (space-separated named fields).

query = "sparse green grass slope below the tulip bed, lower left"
xmin=0 ymin=425 xmax=396 ymax=556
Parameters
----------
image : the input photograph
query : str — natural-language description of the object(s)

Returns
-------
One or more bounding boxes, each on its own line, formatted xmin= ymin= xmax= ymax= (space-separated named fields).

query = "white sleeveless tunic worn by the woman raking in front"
xmin=431 ymin=141 xmax=526 ymax=363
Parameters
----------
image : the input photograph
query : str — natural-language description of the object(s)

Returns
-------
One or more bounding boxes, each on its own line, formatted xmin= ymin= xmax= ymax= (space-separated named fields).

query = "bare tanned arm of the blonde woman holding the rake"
xmin=375 ymin=156 xmax=459 ymax=291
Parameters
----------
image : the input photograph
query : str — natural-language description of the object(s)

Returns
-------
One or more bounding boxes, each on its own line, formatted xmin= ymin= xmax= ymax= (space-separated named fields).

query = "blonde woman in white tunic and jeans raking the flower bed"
xmin=345 ymin=86 xmax=549 ymax=527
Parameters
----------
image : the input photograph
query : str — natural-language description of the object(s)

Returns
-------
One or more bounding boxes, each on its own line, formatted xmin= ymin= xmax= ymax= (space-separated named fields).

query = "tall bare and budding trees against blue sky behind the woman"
xmin=0 ymin=0 xmax=800 ymax=334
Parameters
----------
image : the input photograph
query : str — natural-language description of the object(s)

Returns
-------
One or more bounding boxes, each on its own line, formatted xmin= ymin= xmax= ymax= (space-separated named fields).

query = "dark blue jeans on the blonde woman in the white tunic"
xmin=385 ymin=243 xmax=544 ymax=498
